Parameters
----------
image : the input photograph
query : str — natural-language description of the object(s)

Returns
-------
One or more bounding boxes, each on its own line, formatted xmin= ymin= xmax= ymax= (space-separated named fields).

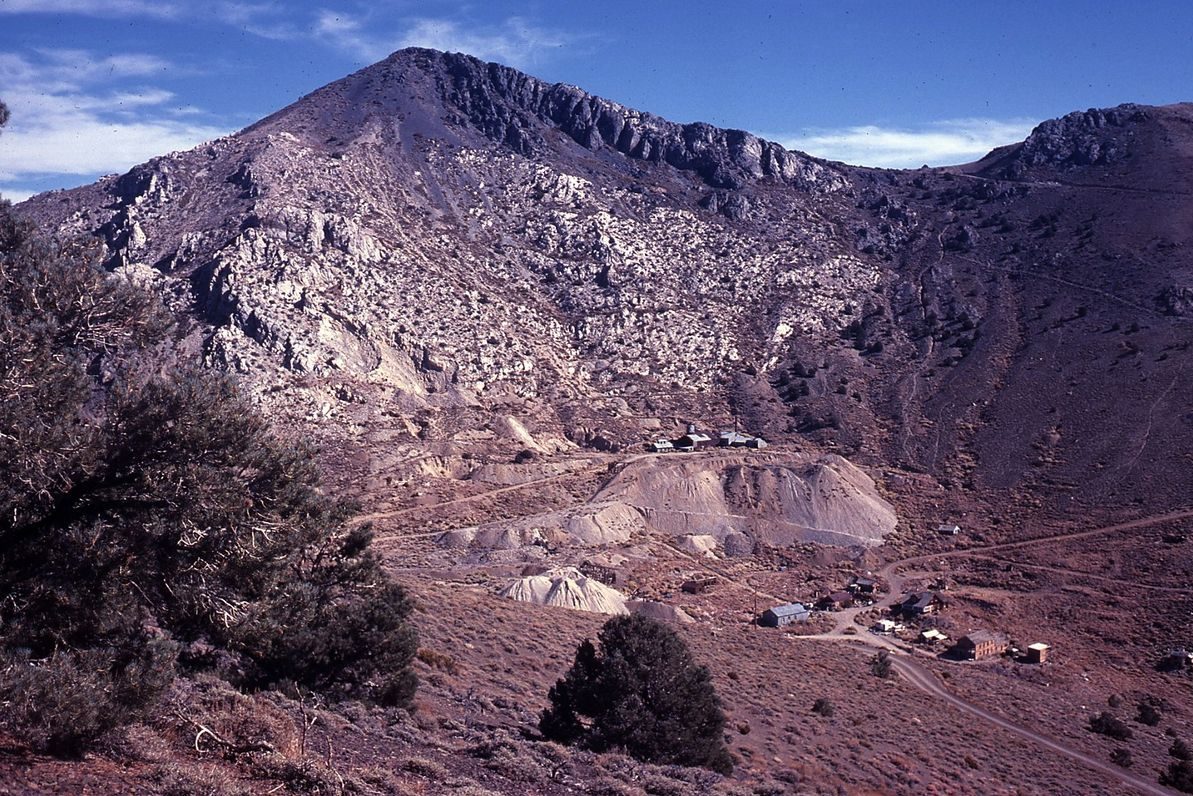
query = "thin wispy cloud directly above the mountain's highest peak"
xmin=315 ymin=11 xmax=573 ymax=67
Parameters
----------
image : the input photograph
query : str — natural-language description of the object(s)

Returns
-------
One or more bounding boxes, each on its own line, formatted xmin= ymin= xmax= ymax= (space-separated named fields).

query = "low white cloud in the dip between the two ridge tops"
xmin=767 ymin=118 xmax=1038 ymax=168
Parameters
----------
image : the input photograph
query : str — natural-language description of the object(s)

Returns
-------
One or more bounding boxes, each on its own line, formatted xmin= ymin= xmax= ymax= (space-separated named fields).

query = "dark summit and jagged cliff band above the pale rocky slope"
xmin=251 ymin=48 xmax=846 ymax=191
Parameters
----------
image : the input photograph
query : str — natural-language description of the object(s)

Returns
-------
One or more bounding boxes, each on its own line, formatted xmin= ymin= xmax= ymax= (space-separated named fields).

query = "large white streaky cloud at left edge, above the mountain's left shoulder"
xmin=0 ymin=50 xmax=228 ymax=190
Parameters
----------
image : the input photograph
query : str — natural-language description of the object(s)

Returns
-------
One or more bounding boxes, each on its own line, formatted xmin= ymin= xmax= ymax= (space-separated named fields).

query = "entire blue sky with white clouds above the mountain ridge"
xmin=0 ymin=0 xmax=1193 ymax=199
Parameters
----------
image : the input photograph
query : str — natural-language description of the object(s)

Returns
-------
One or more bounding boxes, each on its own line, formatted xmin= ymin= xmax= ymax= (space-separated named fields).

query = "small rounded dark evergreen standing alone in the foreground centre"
xmin=539 ymin=616 xmax=733 ymax=773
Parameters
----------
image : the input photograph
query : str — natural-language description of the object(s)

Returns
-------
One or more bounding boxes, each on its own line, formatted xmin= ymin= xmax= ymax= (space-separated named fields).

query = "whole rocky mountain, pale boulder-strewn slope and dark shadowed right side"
xmin=23 ymin=50 xmax=1193 ymax=525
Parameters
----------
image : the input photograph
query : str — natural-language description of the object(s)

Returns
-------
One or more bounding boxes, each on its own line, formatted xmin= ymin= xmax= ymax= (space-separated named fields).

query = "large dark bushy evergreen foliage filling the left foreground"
xmin=0 ymin=153 xmax=416 ymax=753
